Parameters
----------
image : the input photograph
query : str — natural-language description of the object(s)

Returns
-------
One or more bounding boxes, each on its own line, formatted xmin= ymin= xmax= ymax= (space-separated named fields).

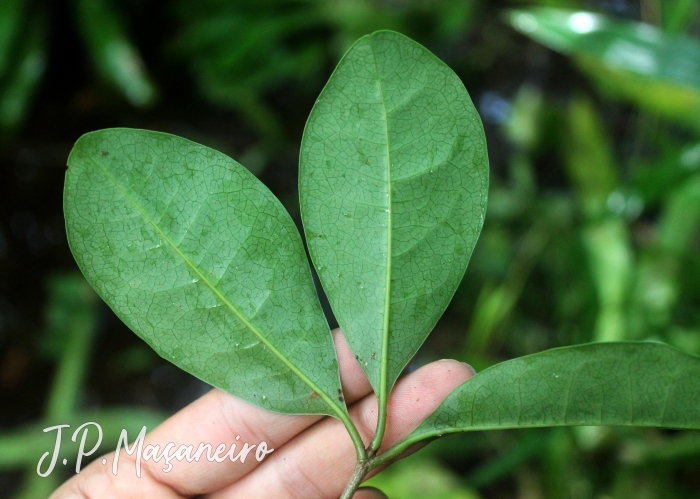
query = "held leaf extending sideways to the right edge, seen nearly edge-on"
xmin=409 ymin=342 xmax=700 ymax=441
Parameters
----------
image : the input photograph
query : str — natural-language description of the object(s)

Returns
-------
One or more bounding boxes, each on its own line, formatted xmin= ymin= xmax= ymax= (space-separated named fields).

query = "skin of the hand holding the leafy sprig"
xmin=49 ymin=329 xmax=474 ymax=499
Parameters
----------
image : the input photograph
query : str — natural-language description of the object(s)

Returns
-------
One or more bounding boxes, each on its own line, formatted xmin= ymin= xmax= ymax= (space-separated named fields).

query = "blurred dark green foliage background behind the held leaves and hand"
xmin=0 ymin=0 xmax=700 ymax=499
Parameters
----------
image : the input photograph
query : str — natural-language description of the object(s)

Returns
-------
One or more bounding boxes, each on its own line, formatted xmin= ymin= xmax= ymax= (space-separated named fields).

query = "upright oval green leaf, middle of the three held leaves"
xmin=299 ymin=31 xmax=488 ymax=399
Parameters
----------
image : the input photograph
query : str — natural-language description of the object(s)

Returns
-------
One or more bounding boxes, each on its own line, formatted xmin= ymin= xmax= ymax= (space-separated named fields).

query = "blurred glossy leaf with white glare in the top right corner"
xmin=508 ymin=7 xmax=700 ymax=129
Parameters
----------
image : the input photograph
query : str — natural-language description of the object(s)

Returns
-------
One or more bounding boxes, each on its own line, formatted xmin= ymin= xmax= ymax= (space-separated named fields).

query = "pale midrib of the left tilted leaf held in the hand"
xmin=86 ymin=156 xmax=344 ymax=419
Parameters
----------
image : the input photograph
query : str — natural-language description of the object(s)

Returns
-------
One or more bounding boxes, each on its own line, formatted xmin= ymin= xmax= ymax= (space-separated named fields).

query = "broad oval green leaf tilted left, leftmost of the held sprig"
xmin=64 ymin=129 xmax=346 ymax=418
